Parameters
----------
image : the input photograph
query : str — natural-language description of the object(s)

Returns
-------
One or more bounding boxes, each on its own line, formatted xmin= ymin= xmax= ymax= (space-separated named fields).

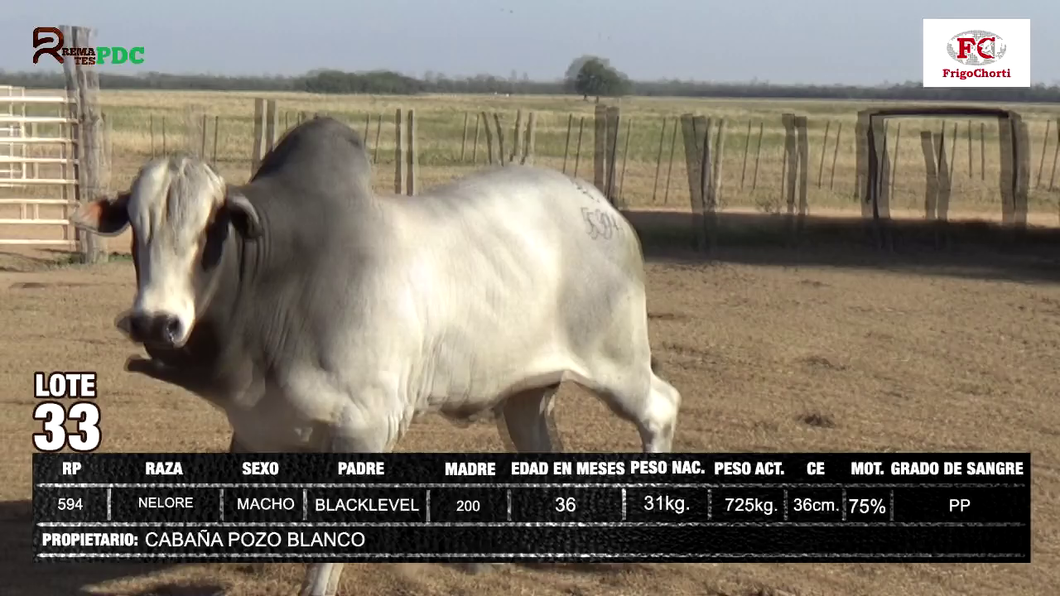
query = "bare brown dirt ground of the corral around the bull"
xmin=0 ymin=234 xmax=1060 ymax=596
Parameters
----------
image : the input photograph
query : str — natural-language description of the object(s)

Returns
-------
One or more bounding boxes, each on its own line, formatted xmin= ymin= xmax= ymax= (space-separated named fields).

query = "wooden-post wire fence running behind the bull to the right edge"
xmin=118 ymin=99 xmax=1060 ymax=249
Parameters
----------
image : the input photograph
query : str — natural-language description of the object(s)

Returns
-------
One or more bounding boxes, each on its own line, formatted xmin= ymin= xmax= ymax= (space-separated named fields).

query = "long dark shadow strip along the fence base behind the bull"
xmin=623 ymin=211 xmax=1060 ymax=282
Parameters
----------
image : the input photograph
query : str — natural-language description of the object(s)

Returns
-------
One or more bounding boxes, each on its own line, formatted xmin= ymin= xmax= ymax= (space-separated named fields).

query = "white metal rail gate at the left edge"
xmin=0 ymin=86 xmax=77 ymax=249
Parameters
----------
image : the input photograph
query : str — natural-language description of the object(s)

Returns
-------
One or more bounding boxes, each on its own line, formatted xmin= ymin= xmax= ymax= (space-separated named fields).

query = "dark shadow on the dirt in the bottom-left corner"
xmin=0 ymin=501 xmax=218 ymax=596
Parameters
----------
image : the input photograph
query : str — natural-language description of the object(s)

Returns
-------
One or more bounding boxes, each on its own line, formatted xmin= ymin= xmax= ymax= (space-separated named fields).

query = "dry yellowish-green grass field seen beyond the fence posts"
xmin=6 ymin=90 xmax=1060 ymax=233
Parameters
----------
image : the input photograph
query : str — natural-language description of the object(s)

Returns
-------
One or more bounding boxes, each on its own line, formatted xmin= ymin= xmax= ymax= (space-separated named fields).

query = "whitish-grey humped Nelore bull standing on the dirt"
xmin=73 ymin=118 xmax=681 ymax=596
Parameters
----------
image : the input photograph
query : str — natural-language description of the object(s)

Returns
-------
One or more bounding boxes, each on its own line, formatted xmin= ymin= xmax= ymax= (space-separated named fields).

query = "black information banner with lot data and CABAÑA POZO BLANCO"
xmin=33 ymin=453 xmax=1030 ymax=563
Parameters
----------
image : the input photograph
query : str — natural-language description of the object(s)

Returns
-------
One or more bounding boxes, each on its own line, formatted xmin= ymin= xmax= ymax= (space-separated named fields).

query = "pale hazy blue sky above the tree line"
xmin=0 ymin=0 xmax=1060 ymax=85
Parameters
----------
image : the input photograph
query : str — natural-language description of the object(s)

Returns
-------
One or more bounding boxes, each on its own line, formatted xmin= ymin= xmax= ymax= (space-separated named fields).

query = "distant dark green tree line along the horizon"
xmin=0 ymin=55 xmax=1060 ymax=103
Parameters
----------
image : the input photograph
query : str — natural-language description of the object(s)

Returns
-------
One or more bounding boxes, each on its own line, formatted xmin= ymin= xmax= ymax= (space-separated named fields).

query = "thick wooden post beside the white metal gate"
xmin=61 ymin=25 xmax=110 ymax=263
